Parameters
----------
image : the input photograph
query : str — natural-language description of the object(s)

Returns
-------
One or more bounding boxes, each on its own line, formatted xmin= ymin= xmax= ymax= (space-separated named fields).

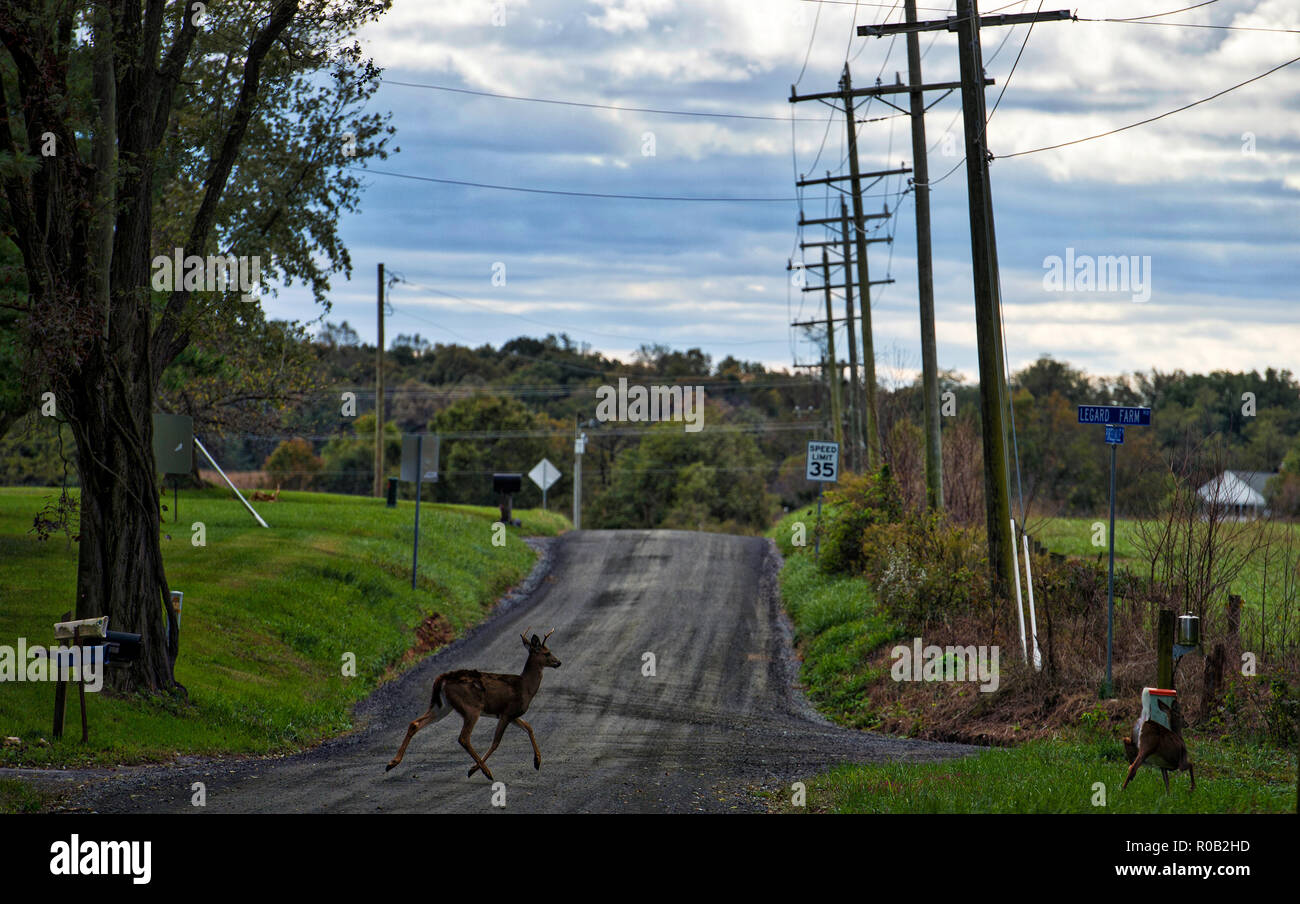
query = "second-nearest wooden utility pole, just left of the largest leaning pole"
xmin=904 ymin=0 xmax=944 ymax=511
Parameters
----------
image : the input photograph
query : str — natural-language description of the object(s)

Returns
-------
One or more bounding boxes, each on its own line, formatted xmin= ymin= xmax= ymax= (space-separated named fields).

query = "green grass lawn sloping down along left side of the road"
xmin=0 ymin=489 xmax=568 ymax=770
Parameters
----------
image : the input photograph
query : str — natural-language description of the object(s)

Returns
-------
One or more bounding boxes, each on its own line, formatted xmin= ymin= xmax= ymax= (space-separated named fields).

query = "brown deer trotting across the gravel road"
xmin=384 ymin=628 xmax=560 ymax=782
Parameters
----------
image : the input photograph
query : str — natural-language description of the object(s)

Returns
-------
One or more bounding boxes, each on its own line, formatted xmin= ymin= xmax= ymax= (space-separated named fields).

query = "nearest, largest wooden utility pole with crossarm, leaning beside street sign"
xmin=858 ymin=0 xmax=1073 ymax=597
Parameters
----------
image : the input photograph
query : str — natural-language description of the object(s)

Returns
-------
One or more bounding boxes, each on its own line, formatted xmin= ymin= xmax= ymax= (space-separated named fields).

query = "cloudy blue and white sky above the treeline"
xmin=258 ymin=0 xmax=1300 ymax=385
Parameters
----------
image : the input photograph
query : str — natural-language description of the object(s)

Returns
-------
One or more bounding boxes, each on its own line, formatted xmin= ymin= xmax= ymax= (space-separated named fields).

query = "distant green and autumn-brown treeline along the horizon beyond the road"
xmin=0 ymin=317 xmax=1300 ymax=531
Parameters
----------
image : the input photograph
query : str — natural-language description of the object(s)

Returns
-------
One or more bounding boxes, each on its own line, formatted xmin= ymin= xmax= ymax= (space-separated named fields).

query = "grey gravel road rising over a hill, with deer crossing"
xmin=65 ymin=531 xmax=971 ymax=813
